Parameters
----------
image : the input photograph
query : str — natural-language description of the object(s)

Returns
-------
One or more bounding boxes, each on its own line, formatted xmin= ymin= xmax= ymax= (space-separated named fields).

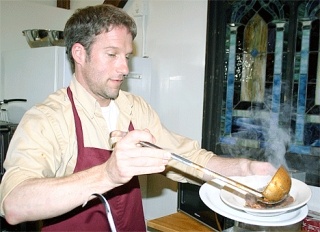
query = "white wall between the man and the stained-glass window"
xmin=125 ymin=0 xmax=207 ymax=219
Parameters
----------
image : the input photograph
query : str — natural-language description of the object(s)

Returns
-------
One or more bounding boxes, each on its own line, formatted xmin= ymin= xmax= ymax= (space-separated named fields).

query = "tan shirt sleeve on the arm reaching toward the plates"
xmin=127 ymin=94 xmax=215 ymax=183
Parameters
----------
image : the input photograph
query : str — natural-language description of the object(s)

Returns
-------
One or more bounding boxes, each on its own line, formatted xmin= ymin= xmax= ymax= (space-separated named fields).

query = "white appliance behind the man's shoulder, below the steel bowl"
xmin=0 ymin=46 xmax=72 ymax=123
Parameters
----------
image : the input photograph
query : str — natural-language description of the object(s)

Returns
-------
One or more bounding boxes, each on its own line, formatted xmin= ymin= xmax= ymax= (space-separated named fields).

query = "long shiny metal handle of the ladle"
xmin=139 ymin=141 xmax=263 ymax=198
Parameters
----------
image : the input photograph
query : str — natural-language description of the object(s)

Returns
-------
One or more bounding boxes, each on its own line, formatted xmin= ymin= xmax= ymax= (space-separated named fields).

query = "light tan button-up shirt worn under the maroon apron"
xmin=0 ymin=77 xmax=213 ymax=215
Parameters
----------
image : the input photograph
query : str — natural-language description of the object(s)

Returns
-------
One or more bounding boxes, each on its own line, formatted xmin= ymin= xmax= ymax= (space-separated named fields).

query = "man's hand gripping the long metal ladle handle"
xmin=106 ymin=130 xmax=171 ymax=184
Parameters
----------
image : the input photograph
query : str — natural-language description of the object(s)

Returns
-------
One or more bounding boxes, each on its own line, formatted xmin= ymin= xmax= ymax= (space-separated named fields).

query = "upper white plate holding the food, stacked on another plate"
xmin=220 ymin=176 xmax=311 ymax=217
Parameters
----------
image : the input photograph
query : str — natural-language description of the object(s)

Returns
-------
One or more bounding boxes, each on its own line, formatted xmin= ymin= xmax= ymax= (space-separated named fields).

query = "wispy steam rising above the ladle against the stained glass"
xmin=222 ymin=87 xmax=291 ymax=168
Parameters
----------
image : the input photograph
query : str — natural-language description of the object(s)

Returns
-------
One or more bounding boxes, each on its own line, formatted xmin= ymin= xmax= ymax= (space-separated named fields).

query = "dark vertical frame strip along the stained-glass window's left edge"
xmin=202 ymin=1 xmax=226 ymax=154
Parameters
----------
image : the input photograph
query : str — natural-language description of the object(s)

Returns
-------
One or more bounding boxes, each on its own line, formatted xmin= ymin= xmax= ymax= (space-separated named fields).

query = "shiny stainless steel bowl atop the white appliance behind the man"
xmin=22 ymin=29 xmax=64 ymax=48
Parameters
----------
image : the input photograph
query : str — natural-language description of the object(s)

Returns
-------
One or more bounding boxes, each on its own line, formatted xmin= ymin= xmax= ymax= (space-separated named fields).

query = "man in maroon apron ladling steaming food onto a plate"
xmin=0 ymin=5 xmax=274 ymax=231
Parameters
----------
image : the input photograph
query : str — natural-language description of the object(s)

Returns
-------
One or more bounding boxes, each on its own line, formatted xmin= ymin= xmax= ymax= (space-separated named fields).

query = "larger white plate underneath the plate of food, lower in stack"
xmin=199 ymin=181 xmax=308 ymax=226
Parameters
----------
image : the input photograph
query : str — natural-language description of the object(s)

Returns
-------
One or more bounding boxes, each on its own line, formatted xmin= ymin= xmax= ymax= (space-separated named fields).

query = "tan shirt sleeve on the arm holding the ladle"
xmin=0 ymin=99 xmax=75 ymax=215
